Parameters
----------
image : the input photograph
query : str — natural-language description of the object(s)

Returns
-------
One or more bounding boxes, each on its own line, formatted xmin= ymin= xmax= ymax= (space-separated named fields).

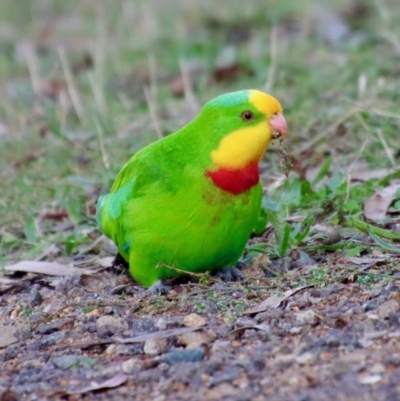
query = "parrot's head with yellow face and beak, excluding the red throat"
xmin=202 ymin=90 xmax=287 ymax=170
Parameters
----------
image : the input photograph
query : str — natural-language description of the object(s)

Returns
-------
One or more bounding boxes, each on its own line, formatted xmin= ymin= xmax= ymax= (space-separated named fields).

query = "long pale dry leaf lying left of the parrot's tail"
xmin=3 ymin=260 xmax=93 ymax=276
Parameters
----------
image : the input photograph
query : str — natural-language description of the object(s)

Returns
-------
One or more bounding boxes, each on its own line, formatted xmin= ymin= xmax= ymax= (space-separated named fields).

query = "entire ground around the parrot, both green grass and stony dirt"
xmin=0 ymin=0 xmax=400 ymax=401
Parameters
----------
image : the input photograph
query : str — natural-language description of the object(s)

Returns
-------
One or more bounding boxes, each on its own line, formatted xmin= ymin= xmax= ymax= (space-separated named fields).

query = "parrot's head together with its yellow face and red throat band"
xmin=201 ymin=90 xmax=287 ymax=194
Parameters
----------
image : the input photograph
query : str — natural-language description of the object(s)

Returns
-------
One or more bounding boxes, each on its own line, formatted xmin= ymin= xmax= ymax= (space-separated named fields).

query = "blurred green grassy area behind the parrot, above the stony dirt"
xmin=0 ymin=0 xmax=400 ymax=262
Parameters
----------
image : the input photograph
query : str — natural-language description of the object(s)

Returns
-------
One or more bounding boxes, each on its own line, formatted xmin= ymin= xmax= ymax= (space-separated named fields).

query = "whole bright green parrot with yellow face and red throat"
xmin=96 ymin=90 xmax=287 ymax=293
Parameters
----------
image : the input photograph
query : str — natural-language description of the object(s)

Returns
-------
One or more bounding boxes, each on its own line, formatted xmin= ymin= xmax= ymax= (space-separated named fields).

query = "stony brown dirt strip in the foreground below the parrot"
xmin=0 ymin=255 xmax=400 ymax=401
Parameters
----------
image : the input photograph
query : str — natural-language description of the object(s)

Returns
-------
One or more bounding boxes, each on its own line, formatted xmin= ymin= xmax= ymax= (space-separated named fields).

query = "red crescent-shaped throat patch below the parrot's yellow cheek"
xmin=206 ymin=163 xmax=260 ymax=195
